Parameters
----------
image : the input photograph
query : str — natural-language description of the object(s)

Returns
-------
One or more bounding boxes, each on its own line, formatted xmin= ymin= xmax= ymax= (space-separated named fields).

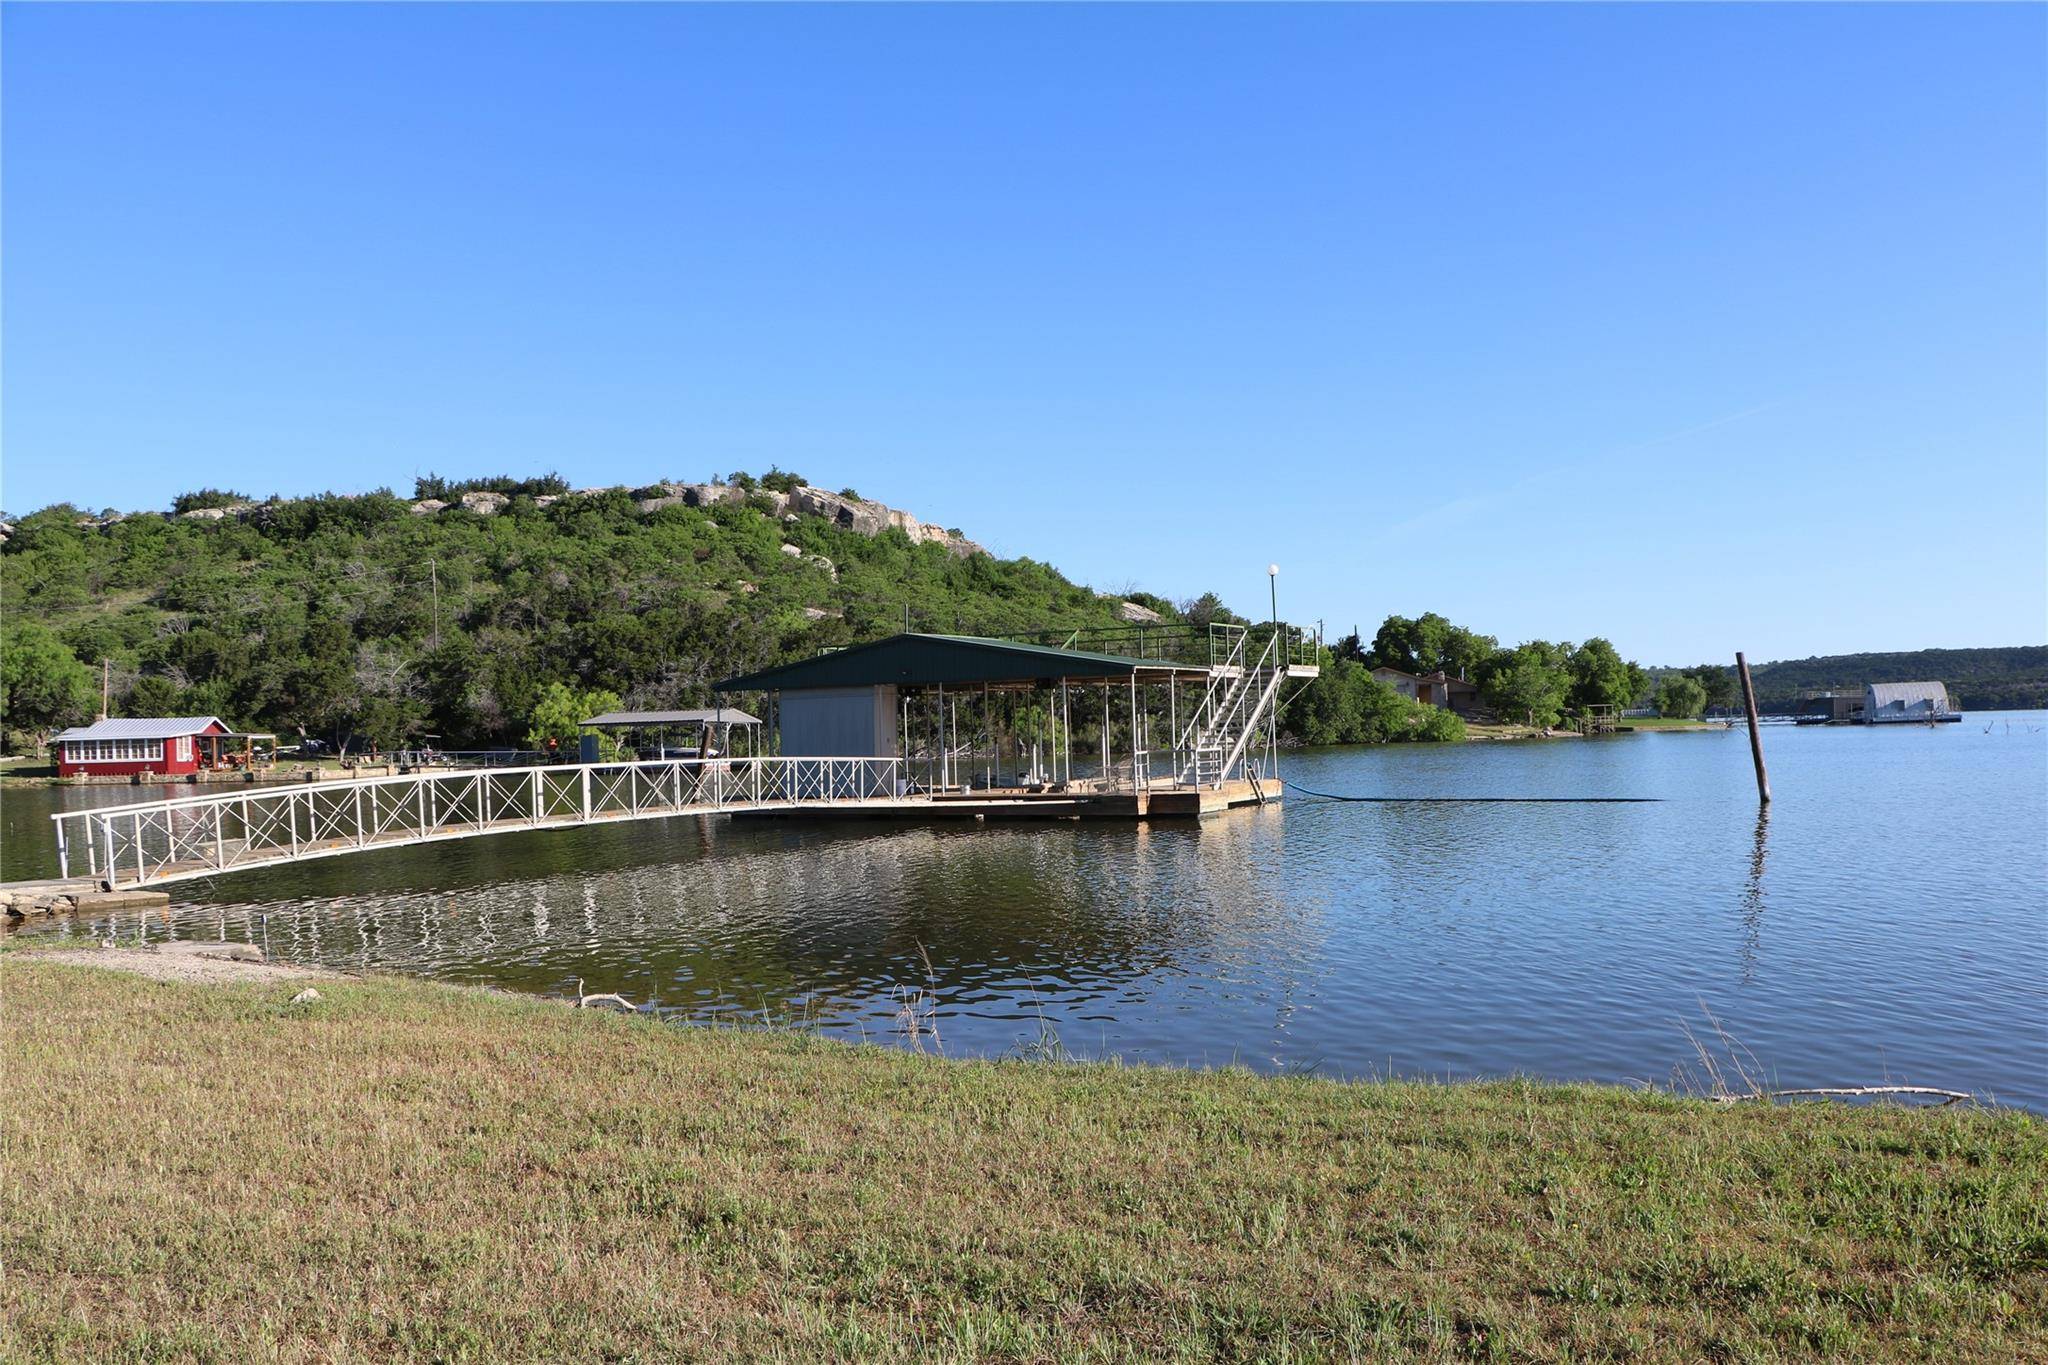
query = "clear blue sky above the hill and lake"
xmin=0 ymin=6 xmax=2048 ymax=663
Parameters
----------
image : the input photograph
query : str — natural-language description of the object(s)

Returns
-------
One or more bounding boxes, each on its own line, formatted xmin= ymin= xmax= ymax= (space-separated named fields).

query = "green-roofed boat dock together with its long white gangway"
xmin=16 ymin=626 xmax=1319 ymax=911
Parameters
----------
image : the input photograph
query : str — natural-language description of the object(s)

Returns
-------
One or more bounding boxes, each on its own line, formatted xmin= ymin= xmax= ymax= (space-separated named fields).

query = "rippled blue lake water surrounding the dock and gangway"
xmin=0 ymin=712 xmax=2048 ymax=1109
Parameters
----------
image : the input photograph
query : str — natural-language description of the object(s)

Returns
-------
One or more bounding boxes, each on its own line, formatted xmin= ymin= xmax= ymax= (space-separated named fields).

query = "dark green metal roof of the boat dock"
xmin=713 ymin=634 xmax=1208 ymax=692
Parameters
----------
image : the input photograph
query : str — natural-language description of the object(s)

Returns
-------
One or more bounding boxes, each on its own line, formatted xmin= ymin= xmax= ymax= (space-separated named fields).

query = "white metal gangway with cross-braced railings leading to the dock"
xmin=49 ymin=757 xmax=905 ymax=888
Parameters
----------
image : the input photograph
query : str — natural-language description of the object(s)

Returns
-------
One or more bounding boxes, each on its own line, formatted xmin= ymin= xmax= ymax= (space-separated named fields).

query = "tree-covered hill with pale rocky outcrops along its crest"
xmin=0 ymin=471 xmax=1178 ymax=747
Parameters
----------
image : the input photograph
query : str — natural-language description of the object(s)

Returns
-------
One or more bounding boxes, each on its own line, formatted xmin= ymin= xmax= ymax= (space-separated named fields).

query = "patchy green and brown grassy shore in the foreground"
xmin=0 ymin=965 xmax=2048 ymax=1361
